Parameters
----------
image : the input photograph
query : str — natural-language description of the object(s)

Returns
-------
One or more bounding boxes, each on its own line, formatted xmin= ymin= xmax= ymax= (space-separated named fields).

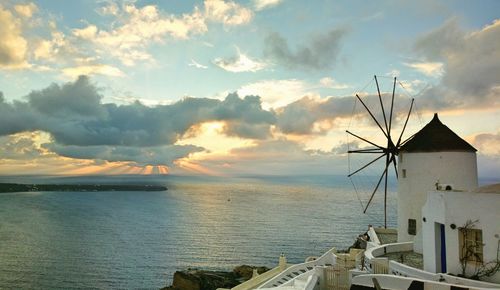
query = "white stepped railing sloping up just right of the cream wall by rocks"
xmin=258 ymin=248 xmax=337 ymax=289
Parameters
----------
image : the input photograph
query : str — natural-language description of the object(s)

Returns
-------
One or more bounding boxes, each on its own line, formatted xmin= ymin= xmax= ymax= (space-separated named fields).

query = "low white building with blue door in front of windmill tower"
xmin=422 ymin=186 xmax=500 ymax=283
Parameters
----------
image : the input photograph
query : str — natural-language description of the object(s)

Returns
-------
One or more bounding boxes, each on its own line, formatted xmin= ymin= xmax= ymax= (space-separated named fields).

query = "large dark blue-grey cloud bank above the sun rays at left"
xmin=0 ymin=76 xmax=276 ymax=164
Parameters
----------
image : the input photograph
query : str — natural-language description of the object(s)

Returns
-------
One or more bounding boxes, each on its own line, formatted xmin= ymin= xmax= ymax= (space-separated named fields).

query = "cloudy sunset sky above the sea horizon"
xmin=0 ymin=0 xmax=500 ymax=178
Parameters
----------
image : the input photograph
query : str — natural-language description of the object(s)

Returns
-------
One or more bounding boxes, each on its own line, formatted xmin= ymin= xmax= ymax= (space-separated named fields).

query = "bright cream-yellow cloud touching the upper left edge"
xmin=0 ymin=5 xmax=30 ymax=69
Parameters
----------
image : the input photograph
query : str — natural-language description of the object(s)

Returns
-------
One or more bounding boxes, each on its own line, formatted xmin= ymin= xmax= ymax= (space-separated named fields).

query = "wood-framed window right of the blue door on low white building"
xmin=458 ymin=228 xmax=483 ymax=263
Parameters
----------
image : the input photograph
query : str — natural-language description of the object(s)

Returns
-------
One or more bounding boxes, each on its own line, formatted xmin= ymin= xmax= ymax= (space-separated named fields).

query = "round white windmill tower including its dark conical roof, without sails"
xmin=398 ymin=114 xmax=478 ymax=246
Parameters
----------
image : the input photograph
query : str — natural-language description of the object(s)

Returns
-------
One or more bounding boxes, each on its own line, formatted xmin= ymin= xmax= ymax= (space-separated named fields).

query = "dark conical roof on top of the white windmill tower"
xmin=400 ymin=113 xmax=477 ymax=152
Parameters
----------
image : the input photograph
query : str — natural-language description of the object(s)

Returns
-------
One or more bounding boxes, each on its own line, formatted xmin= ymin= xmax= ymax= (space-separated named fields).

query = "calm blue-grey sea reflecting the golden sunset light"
xmin=0 ymin=176 xmax=396 ymax=289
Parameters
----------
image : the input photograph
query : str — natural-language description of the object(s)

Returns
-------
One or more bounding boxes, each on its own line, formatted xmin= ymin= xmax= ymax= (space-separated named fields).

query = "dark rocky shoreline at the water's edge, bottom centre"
xmin=162 ymin=265 xmax=269 ymax=290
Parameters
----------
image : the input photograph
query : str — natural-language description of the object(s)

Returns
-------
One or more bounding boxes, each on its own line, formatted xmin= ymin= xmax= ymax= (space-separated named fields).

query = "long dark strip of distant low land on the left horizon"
xmin=0 ymin=183 xmax=167 ymax=193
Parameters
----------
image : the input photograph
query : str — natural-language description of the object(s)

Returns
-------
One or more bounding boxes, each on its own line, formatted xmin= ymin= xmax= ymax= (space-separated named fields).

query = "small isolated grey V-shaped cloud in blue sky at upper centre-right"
xmin=264 ymin=28 xmax=347 ymax=70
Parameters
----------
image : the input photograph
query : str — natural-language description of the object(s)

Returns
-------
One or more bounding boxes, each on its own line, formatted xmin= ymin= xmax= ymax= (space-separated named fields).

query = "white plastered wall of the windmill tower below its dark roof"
xmin=398 ymin=152 xmax=478 ymax=242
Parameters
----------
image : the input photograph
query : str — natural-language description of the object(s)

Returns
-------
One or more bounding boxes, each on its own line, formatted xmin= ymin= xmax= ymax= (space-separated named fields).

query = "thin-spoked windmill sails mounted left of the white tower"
xmin=346 ymin=76 xmax=414 ymax=227
